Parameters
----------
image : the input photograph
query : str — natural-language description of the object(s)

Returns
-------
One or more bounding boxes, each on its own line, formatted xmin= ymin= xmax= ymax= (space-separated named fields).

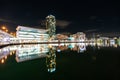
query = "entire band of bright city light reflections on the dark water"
xmin=0 ymin=43 xmax=118 ymax=72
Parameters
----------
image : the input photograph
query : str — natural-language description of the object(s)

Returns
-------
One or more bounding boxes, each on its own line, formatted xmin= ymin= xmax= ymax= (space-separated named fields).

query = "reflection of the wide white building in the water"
xmin=16 ymin=44 xmax=49 ymax=62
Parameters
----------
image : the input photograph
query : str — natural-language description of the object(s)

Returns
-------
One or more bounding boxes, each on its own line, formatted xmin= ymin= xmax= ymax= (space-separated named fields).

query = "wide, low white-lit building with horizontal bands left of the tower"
xmin=16 ymin=26 xmax=49 ymax=43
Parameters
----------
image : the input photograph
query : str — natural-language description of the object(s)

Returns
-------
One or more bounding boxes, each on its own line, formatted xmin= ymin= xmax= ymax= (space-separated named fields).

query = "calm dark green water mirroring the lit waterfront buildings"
xmin=0 ymin=43 xmax=120 ymax=80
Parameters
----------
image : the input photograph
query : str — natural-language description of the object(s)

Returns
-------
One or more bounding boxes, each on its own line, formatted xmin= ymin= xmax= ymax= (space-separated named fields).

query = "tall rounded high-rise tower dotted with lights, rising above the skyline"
xmin=46 ymin=15 xmax=56 ymax=39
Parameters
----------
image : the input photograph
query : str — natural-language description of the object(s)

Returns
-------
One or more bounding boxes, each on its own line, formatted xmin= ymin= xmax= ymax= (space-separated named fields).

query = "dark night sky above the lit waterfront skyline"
xmin=0 ymin=0 xmax=120 ymax=33
